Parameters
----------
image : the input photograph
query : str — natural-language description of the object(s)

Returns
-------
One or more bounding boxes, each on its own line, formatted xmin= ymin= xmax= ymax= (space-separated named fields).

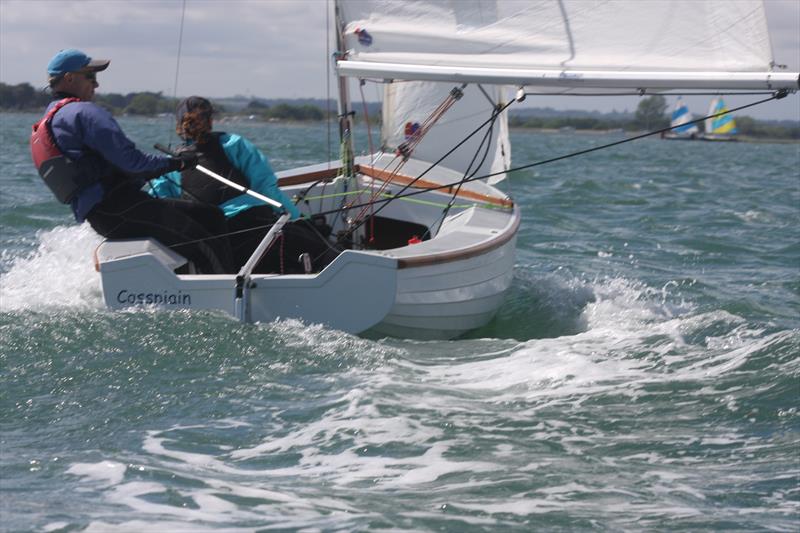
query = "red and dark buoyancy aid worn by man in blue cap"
xmin=30 ymin=97 xmax=97 ymax=204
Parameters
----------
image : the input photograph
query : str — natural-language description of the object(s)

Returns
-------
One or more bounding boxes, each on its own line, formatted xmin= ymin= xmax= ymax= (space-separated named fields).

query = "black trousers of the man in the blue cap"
xmin=86 ymin=186 xmax=235 ymax=274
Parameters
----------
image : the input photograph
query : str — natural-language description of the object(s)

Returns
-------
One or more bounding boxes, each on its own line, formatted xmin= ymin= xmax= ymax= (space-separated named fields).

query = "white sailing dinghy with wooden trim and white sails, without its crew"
xmin=96 ymin=0 xmax=798 ymax=339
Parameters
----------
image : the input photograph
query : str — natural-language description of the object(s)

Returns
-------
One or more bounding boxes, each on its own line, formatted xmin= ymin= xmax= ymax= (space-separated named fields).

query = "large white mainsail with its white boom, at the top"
xmin=337 ymin=0 xmax=798 ymax=91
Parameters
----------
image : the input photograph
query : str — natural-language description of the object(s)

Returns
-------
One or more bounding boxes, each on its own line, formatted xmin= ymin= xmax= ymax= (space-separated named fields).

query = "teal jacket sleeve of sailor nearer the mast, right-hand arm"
xmin=220 ymin=133 xmax=300 ymax=220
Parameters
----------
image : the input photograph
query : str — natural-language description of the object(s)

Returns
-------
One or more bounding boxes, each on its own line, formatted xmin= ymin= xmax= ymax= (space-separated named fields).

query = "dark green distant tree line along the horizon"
xmin=0 ymin=83 xmax=800 ymax=140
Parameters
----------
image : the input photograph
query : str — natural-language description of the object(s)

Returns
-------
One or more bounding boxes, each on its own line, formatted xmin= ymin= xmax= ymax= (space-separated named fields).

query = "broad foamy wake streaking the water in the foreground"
xmin=45 ymin=270 xmax=800 ymax=531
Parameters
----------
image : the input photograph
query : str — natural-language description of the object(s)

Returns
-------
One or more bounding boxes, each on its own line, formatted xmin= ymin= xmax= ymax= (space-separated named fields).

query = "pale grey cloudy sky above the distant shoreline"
xmin=0 ymin=0 xmax=800 ymax=120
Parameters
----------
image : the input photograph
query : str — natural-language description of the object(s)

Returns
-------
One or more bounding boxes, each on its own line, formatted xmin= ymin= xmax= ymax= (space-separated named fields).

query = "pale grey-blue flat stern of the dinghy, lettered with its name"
xmin=98 ymin=239 xmax=397 ymax=333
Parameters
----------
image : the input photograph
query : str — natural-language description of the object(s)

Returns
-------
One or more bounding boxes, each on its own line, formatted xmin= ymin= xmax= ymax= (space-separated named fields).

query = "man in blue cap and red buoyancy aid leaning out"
xmin=31 ymin=48 xmax=233 ymax=273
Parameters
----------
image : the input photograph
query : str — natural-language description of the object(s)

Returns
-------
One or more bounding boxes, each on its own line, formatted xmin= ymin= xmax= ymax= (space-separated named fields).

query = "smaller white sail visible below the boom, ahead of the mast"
xmin=381 ymin=82 xmax=511 ymax=183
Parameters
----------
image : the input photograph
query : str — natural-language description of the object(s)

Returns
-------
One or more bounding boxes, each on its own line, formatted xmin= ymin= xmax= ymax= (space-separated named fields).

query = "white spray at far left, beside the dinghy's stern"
xmin=0 ymin=224 xmax=102 ymax=311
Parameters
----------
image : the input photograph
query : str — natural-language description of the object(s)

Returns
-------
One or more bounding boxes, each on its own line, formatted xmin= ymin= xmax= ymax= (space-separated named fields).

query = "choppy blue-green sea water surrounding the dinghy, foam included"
xmin=0 ymin=110 xmax=800 ymax=532
